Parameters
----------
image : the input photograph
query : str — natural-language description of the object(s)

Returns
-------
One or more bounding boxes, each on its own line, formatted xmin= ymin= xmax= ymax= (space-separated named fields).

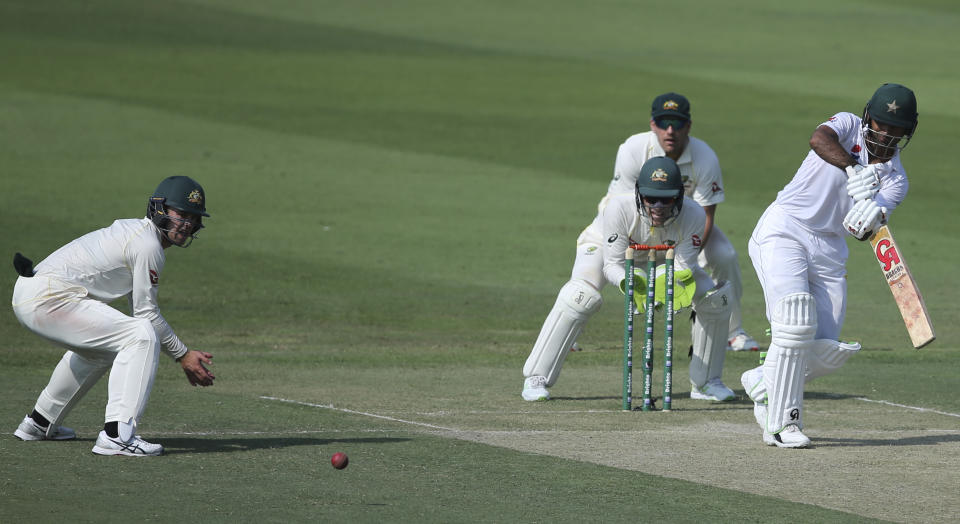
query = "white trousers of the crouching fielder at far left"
xmin=13 ymin=275 xmax=160 ymax=424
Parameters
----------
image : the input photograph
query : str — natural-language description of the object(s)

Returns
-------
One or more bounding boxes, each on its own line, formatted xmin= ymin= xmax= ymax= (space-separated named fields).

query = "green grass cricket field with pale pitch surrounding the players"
xmin=0 ymin=0 xmax=960 ymax=522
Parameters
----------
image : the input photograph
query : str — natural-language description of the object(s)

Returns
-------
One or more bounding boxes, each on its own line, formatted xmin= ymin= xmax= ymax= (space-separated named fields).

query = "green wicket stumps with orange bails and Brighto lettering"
xmin=623 ymin=241 xmax=674 ymax=411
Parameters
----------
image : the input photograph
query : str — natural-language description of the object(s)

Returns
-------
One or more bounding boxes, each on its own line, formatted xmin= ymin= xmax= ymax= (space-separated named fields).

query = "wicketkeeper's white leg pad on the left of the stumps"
xmin=523 ymin=280 xmax=603 ymax=386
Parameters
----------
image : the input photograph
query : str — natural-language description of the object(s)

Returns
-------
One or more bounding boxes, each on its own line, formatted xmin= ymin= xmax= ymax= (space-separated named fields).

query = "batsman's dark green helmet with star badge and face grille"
xmin=861 ymin=84 xmax=917 ymax=161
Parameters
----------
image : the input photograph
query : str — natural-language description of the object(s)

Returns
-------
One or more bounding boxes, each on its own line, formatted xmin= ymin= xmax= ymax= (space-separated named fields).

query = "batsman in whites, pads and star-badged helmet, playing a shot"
xmin=741 ymin=84 xmax=917 ymax=448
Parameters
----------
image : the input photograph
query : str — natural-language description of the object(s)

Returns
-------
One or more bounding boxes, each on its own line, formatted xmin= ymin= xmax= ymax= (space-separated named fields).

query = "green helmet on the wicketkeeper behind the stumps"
xmin=634 ymin=156 xmax=683 ymax=226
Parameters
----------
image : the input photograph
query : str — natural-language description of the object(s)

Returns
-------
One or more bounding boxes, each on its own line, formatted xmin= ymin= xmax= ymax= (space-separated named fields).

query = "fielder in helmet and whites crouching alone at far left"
xmin=13 ymin=176 xmax=214 ymax=456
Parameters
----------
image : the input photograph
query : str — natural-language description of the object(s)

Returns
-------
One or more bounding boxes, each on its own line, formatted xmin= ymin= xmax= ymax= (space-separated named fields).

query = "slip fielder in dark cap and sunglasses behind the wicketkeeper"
xmin=612 ymin=93 xmax=759 ymax=351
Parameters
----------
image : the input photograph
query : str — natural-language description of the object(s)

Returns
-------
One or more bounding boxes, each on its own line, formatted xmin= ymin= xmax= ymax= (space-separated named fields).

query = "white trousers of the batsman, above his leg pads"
xmin=748 ymin=204 xmax=849 ymax=340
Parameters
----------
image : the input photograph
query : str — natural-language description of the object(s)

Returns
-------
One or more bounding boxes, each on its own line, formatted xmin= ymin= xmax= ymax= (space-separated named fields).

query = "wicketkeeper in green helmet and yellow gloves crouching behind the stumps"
xmin=522 ymin=157 xmax=735 ymax=401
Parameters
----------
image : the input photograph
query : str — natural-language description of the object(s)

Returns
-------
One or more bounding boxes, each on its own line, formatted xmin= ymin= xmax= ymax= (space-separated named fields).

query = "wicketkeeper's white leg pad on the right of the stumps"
xmin=690 ymin=282 xmax=732 ymax=387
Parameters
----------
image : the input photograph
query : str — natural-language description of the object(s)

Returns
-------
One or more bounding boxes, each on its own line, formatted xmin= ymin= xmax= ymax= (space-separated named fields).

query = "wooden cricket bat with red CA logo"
xmin=870 ymin=226 xmax=937 ymax=349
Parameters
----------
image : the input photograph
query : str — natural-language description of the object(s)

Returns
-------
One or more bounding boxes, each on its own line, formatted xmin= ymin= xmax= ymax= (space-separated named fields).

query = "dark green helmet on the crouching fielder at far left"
xmin=147 ymin=176 xmax=210 ymax=247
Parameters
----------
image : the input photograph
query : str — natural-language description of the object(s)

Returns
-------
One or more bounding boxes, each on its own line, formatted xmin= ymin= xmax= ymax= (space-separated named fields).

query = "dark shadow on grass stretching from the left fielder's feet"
xmin=156 ymin=437 xmax=410 ymax=455
